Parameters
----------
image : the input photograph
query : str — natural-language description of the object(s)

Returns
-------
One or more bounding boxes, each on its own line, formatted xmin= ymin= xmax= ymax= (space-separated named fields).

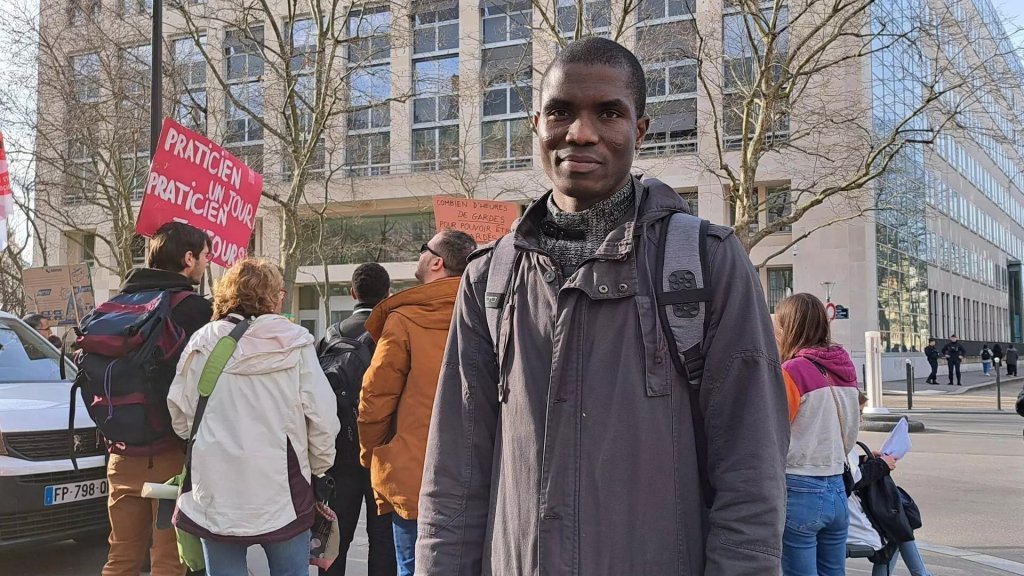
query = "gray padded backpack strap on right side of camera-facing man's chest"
xmin=653 ymin=212 xmax=715 ymax=505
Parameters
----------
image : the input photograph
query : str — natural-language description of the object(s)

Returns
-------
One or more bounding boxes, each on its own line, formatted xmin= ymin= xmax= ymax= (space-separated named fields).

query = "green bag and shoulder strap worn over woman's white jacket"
xmin=167 ymin=319 xmax=251 ymax=572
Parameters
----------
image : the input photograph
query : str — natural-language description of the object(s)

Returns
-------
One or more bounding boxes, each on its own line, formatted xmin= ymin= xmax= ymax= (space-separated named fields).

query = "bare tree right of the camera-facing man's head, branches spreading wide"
xmin=531 ymin=0 xmax=1021 ymax=266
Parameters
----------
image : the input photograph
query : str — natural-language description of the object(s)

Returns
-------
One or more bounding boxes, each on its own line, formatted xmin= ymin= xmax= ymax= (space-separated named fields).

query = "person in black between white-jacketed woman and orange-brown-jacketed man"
xmin=316 ymin=262 xmax=397 ymax=576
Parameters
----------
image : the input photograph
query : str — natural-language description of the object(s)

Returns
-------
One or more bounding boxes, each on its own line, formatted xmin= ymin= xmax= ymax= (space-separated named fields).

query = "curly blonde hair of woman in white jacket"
xmin=213 ymin=258 xmax=285 ymax=320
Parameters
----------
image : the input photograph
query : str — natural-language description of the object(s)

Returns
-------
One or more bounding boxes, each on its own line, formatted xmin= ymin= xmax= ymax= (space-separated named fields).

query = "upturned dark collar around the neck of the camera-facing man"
xmin=513 ymin=175 xmax=689 ymax=259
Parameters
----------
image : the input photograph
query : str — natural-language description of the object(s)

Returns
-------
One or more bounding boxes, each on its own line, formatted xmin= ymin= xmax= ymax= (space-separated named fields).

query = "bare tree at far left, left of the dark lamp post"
xmin=0 ymin=2 xmax=150 ymax=278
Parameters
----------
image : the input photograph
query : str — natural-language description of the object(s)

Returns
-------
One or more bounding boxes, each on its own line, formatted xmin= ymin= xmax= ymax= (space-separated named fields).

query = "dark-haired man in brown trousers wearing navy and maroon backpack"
xmin=101 ymin=222 xmax=213 ymax=576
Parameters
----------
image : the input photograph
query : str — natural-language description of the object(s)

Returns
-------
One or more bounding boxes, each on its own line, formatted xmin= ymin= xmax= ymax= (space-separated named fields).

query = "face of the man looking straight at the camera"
xmin=534 ymin=64 xmax=650 ymax=210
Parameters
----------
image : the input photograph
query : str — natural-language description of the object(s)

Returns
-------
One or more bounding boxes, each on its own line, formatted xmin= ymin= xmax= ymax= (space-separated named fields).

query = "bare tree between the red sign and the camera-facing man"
xmin=165 ymin=0 xmax=408 ymax=307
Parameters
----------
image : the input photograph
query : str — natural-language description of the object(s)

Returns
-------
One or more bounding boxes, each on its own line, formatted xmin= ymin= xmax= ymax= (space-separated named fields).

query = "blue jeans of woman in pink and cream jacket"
xmin=782 ymin=475 xmax=850 ymax=576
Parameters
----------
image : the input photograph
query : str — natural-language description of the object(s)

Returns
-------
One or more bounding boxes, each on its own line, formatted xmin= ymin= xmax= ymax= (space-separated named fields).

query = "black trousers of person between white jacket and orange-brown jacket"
xmin=319 ymin=463 xmax=398 ymax=576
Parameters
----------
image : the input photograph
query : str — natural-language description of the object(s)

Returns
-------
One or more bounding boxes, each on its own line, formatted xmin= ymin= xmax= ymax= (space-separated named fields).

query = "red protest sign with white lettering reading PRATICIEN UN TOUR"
xmin=135 ymin=118 xmax=263 ymax=266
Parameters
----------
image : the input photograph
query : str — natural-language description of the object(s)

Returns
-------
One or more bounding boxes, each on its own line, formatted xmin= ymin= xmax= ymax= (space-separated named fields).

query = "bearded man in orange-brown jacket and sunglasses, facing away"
xmin=358 ymin=230 xmax=476 ymax=576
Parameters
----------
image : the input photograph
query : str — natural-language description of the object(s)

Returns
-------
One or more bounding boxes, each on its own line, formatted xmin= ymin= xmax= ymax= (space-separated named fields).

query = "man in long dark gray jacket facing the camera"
xmin=416 ymin=38 xmax=790 ymax=576
